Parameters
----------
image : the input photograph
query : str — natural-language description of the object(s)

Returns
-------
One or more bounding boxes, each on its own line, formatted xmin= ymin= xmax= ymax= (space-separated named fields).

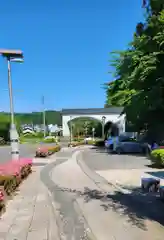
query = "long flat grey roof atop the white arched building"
xmin=61 ymin=107 xmax=123 ymax=115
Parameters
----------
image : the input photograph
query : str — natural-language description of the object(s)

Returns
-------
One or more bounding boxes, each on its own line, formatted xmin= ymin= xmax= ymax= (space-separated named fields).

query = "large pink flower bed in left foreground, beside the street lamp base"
xmin=0 ymin=159 xmax=32 ymax=212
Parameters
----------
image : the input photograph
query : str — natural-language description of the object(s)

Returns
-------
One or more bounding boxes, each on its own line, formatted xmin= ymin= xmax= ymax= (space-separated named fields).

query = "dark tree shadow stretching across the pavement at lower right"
xmin=55 ymin=186 xmax=164 ymax=230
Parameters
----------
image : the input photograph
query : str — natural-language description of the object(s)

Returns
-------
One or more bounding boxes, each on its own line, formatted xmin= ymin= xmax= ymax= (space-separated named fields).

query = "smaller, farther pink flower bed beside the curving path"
xmin=36 ymin=145 xmax=61 ymax=157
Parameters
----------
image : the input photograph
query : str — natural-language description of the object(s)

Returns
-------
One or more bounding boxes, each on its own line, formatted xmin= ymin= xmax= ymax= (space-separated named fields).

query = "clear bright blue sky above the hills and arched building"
xmin=0 ymin=0 xmax=143 ymax=112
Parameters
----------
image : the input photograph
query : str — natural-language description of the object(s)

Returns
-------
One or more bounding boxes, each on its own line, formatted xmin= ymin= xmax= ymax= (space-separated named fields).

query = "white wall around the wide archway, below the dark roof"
xmin=62 ymin=114 xmax=125 ymax=137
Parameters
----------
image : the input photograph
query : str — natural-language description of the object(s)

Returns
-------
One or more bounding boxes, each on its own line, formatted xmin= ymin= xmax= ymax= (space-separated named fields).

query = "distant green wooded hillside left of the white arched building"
xmin=0 ymin=110 xmax=62 ymax=125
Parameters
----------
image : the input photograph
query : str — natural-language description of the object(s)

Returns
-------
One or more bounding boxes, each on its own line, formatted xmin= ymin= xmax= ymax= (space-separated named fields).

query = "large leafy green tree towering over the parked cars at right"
xmin=105 ymin=0 xmax=164 ymax=142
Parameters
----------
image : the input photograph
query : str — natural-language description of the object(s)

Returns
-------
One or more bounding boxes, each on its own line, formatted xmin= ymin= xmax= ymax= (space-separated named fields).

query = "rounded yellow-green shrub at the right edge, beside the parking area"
xmin=150 ymin=148 xmax=164 ymax=167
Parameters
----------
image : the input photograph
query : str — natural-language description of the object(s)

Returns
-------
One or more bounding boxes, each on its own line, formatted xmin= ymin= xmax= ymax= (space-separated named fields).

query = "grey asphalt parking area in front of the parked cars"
xmin=83 ymin=148 xmax=150 ymax=171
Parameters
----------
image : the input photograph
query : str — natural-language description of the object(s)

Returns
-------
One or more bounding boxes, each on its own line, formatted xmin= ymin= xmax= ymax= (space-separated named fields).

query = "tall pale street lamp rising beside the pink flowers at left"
xmin=0 ymin=49 xmax=23 ymax=160
